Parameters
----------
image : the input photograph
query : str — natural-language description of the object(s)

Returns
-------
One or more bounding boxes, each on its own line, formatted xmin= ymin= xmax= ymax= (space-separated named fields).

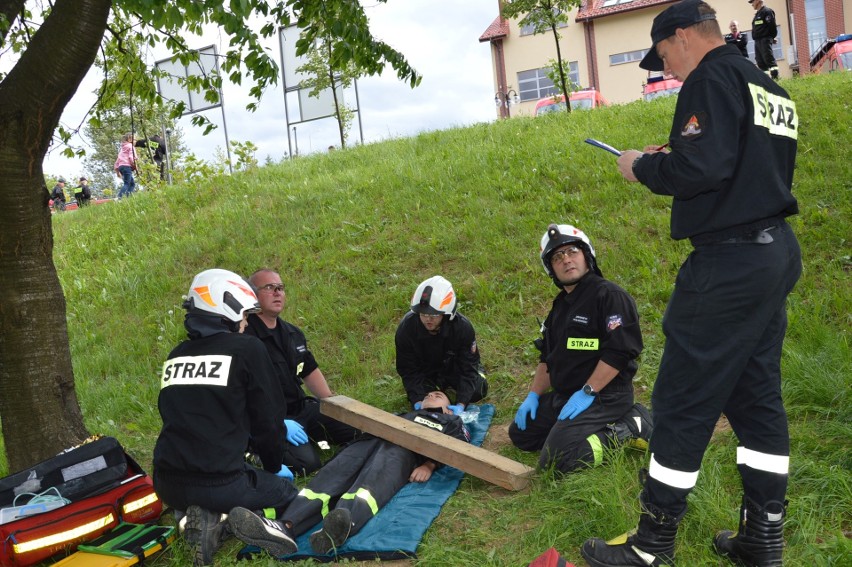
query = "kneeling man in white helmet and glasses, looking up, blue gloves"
xmin=509 ymin=224 xmax=651 ymax=473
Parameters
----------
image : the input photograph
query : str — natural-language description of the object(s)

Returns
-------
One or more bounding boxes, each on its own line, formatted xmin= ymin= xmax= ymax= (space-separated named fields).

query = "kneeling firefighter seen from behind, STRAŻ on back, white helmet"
xmin=154 ymin=269 xmax=296 ymax=565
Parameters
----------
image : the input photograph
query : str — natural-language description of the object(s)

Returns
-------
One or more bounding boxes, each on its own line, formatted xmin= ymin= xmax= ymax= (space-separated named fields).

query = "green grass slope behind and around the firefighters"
xmin=25 ymin=73 xmax=852 ymax=566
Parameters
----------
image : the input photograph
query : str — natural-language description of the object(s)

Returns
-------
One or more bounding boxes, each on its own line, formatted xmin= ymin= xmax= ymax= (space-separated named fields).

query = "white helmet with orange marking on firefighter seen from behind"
xmin=184 ymin=269 xmax=260 ymax=323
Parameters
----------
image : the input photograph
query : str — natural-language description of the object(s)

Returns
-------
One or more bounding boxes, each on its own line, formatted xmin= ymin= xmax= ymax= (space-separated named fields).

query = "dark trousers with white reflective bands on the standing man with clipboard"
xmin=646 ymin=221 xmax=802 ymax=515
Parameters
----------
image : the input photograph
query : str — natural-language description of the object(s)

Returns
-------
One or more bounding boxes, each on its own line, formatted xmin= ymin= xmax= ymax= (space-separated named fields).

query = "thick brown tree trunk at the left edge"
xmin=0 ymin=0 xmax=112 ymax=471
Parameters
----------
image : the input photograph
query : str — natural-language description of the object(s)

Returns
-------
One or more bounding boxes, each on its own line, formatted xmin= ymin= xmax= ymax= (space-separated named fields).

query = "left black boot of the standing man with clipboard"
xmin=580 ymin=492 xmax=683 ymax=567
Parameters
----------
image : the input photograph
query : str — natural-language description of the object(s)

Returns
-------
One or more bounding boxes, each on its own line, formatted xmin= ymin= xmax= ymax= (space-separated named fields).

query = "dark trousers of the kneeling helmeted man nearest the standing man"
xmin=509 ymin=383 xmax=633 ymax=473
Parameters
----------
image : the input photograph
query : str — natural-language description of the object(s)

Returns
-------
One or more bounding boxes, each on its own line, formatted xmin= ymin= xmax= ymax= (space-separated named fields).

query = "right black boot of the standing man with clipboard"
xmin=713 ymin=496 xmax=787 ymax=567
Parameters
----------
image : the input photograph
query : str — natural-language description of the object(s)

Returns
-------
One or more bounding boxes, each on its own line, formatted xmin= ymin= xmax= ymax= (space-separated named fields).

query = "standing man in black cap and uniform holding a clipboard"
xmin=582 ymin=0 xmax=802 ymax=566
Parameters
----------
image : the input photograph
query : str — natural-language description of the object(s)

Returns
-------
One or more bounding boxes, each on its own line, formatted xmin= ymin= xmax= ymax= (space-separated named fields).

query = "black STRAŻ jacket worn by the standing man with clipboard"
xmin=633 ymin=45 xmax=799 ymax=239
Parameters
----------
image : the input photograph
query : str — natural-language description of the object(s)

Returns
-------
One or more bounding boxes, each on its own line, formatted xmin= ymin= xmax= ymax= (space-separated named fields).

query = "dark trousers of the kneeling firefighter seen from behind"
xmin=154 ymin=464 xmax=296 ymax=514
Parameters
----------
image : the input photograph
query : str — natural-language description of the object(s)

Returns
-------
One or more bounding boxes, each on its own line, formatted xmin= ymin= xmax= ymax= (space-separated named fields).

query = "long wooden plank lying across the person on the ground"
xmin=320 ymin=396 xmax=535 ymax=490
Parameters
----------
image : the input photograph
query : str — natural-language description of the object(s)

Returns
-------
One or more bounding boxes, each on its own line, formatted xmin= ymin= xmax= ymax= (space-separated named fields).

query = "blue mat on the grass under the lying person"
xmin=240 ymin=404 xmax=494 ymax=563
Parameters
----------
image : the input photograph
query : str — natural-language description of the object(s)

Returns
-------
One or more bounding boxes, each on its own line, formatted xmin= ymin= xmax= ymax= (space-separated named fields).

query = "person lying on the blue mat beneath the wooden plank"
xmin=240 ymin=391 xmax=470 ymax=554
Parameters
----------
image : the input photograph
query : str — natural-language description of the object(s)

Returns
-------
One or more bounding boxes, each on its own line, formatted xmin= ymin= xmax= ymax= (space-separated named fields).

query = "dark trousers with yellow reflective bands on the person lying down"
xmin=279 ymin=438 xmax=419 ymax=535
